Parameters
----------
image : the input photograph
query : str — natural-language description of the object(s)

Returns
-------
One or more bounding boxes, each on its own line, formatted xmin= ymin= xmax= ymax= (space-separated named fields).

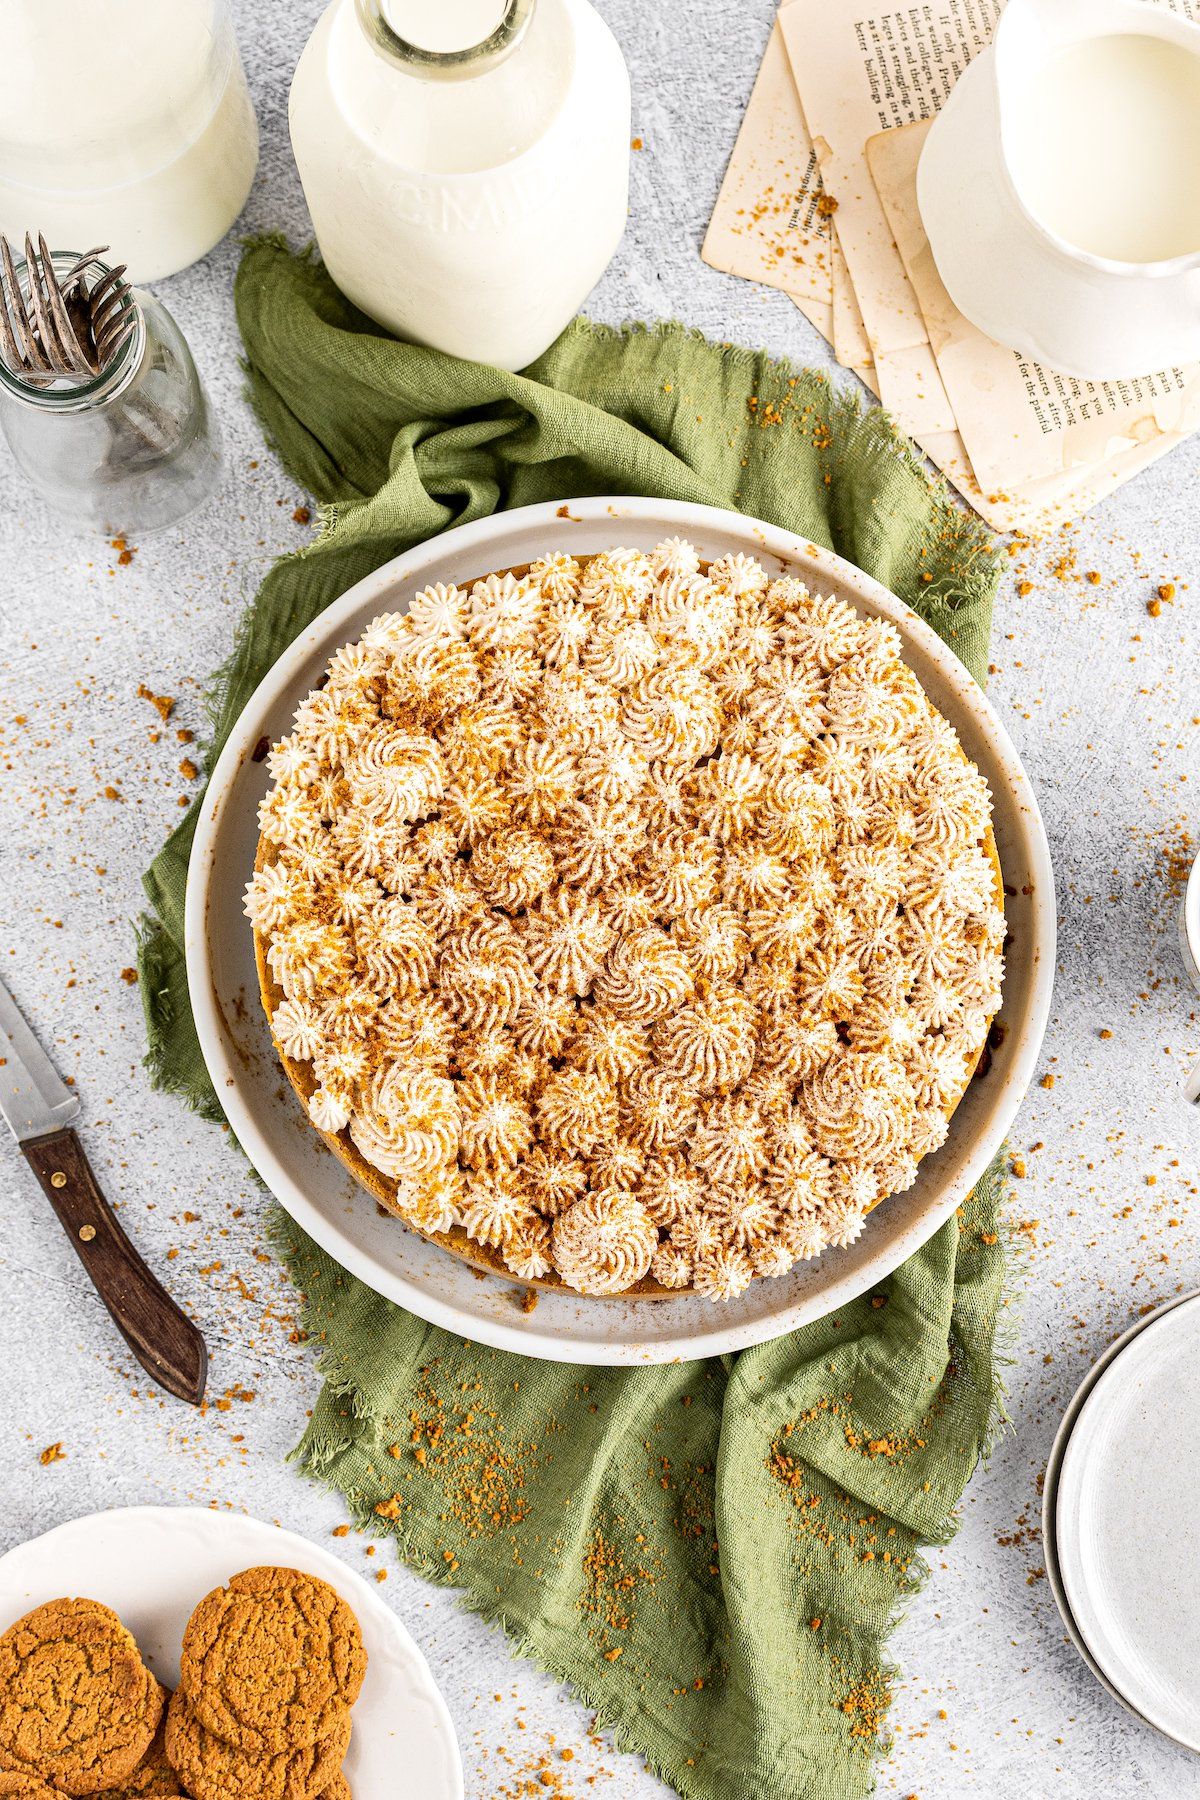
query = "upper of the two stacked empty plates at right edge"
xmin=1054 ymin=1296 xmax=1200 ymax=1751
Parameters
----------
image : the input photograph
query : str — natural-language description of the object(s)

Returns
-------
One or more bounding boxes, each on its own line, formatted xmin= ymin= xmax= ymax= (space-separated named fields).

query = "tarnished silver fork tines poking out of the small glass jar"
xmin=0 ymin=232 xmax=137 ymax=387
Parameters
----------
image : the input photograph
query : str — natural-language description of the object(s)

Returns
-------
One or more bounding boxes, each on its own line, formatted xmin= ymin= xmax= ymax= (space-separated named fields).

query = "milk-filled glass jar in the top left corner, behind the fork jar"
xmin=0 ymin=0 xmax=259 ymax=281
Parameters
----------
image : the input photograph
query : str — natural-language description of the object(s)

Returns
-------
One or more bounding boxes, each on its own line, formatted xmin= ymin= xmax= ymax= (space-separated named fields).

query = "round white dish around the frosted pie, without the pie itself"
xmin=185 ymin=499 xmax=1054 ymax=1364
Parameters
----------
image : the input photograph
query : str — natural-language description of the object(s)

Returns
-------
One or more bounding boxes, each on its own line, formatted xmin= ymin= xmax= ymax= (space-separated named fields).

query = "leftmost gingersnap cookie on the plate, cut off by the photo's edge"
xmin=0 ymin=1600 xmax=164 ymax=1795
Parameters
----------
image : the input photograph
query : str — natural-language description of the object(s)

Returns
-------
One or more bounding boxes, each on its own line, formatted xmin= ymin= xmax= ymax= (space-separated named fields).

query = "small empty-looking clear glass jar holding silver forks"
xmin=0 ymin=239 xmax=219 ymax=536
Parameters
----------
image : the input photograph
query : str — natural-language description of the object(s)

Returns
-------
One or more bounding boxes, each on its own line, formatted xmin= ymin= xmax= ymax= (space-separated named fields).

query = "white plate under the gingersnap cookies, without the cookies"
xmin=0 ymin=1507 xmax=462 ymax=1800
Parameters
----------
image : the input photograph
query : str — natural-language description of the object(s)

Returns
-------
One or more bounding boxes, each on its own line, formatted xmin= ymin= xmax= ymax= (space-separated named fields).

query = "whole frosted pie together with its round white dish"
xmin=185 ymin=499 xmax=1054 ymax=1364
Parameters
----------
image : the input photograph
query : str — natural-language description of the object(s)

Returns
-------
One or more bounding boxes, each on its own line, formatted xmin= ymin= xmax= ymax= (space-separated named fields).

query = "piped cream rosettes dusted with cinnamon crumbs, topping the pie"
xmin=246 ymin=538 xmax=1004 ymax=1300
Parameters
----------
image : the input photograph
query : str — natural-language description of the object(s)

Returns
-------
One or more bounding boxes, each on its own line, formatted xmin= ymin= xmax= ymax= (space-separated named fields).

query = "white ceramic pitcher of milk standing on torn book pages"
xmin=918 ymin=0 xmax=1200 ymax=382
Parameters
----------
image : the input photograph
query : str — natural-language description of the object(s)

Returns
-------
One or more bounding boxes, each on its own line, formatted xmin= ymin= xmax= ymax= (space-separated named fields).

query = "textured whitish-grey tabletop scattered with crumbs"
xmin=0 ymin=0 xmax=1200 ymax=1800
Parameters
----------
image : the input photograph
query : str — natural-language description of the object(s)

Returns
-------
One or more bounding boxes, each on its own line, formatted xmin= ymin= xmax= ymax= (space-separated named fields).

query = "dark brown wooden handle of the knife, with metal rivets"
xmin=22 ymin=1130 xmax=209 ymax=1406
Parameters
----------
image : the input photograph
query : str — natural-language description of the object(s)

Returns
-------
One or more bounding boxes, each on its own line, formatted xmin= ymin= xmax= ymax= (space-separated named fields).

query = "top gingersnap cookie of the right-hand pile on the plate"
xmin=180 ymin=1568 xmax=367 ymax=1757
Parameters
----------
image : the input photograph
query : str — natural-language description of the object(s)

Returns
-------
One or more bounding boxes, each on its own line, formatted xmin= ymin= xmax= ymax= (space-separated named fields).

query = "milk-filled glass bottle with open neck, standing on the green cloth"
xmin=290 ymin=0 xmax=630 ymax=369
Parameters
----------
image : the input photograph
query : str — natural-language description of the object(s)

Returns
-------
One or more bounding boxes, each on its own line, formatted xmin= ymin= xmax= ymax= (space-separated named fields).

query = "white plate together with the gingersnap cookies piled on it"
xmin=0 ymin=1507 xmax=462 ymax=1800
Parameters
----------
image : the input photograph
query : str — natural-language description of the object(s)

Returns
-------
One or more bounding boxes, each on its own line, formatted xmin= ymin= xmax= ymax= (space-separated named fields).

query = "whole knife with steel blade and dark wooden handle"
xmin=0 ymin=983 xmax=209 ymax=1406
